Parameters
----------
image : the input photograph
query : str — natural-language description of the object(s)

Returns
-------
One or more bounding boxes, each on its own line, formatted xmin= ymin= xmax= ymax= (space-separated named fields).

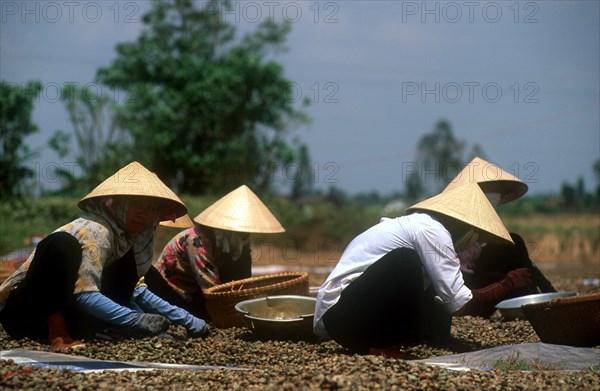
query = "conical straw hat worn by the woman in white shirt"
xmin=406 ymin=183 xmax=514 ymax=244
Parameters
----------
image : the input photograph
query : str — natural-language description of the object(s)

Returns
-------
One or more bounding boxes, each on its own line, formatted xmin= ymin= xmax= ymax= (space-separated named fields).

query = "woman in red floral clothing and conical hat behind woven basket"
xmin=146 ymin=185 xmax=285 ymax=317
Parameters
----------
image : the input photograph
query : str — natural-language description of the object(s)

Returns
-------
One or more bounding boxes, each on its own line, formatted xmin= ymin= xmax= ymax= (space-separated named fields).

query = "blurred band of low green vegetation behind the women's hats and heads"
xmin=0 ymin=192 xmax=600 ymax=254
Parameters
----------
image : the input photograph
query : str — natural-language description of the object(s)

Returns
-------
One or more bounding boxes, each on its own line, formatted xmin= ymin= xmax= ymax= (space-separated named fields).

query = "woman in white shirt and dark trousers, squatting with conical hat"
xmin=314 ymin=184 xmax=531 ymax=357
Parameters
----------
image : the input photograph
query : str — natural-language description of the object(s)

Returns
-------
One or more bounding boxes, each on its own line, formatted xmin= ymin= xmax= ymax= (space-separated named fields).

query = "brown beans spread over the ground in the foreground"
xmin=0 ymin=265 xmax=600 ymax=390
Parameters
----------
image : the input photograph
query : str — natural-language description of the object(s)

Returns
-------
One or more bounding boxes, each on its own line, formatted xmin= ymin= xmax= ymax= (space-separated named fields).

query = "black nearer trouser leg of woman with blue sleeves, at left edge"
xmin=0 ymin=232 xmax=81 ymax=339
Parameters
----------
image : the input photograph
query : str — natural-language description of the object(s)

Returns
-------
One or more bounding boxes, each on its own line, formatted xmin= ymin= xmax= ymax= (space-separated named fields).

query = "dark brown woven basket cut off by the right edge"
xmin=521 ymin=292 xmax=600 ymax=347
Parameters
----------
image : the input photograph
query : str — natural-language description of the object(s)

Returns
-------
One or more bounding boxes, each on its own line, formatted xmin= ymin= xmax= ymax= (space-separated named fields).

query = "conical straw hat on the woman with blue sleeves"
xmin=77 ymin=162 xmax=187 ymax=217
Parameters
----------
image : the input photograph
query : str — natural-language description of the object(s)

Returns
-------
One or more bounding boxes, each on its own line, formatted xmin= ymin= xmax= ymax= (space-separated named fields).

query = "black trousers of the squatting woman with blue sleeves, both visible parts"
xmin=0 ymin=232 xmax=145 ymax=339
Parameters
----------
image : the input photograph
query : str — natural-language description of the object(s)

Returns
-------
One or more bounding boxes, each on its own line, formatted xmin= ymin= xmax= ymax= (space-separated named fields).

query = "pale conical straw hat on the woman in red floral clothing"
xmin=194 ymin=185 xmax=285 ymax=233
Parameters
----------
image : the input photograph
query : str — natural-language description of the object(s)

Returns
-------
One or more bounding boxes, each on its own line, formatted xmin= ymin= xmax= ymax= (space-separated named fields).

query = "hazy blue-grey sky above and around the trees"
xmin=0 ymin=1 xmax=600 ymax=194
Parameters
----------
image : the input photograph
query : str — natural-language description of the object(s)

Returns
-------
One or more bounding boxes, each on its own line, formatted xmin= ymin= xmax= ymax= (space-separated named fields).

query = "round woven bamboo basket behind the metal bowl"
xmin=204 ymin=272 xmax=308 ymax=328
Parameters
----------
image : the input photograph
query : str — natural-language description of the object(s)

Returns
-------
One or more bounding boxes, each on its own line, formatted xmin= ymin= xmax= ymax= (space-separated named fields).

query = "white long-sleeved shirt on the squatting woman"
xmin=313 ymin=213 xmax=473 ymax=338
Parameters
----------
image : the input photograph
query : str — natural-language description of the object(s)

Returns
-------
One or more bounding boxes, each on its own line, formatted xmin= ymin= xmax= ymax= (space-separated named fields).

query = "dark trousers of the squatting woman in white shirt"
xmin=323 ymin=248 xmax=452 ymax=353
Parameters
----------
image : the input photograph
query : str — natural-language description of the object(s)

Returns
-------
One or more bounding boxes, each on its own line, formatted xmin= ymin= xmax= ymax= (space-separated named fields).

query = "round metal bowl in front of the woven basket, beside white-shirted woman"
xmin=235 ymin=295 xmax=317 ymax=340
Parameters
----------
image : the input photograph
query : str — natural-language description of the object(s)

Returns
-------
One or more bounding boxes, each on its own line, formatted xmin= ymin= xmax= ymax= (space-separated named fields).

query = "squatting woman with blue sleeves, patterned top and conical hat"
xmin=0 ymin=162 xmax=208 ymax=348
